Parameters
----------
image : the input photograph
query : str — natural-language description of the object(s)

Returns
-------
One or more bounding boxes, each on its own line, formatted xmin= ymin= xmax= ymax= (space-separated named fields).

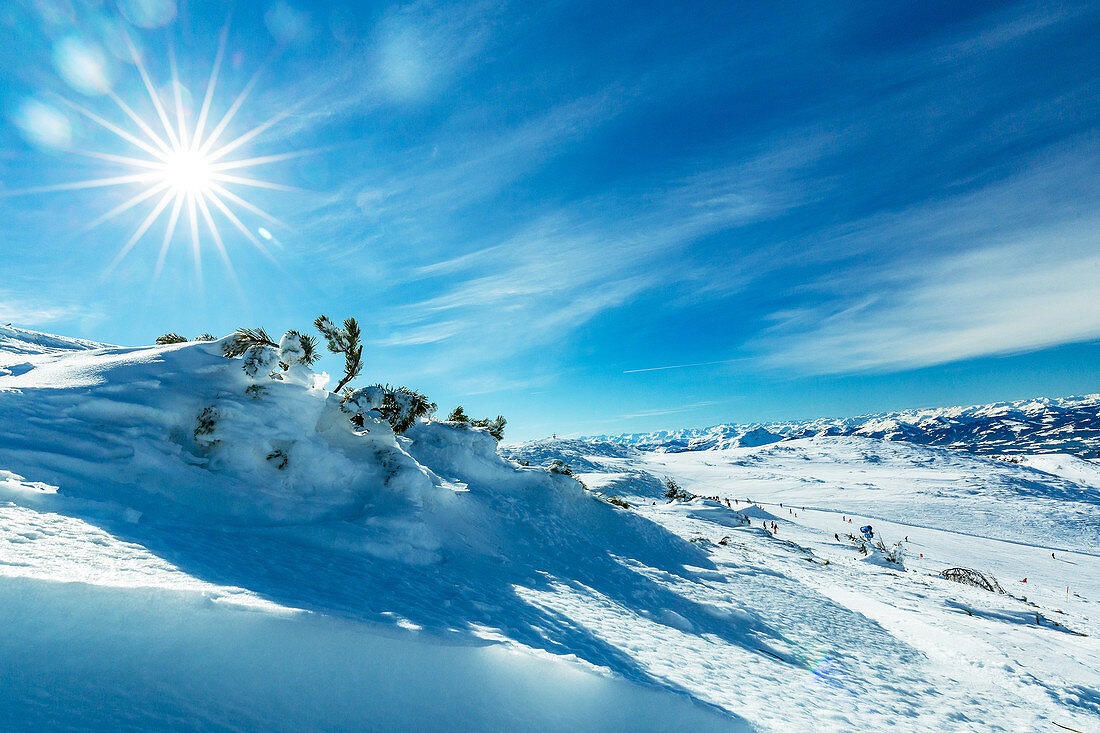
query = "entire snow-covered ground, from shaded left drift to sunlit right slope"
xmin=0 ymin=329 xmax=1100 ymax=731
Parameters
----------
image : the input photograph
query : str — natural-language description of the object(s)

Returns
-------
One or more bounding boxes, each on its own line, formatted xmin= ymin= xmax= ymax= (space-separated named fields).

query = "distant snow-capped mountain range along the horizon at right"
xmin=590 ymin=394 xmax=1100 ymax=458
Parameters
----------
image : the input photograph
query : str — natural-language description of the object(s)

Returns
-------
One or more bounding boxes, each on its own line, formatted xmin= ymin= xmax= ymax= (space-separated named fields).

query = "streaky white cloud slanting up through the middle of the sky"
xmin=378 ymin=144 xmax=818 ymax=361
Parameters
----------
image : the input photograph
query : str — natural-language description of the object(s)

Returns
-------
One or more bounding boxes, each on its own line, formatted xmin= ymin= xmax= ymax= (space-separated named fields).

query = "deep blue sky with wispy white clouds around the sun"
xmin=0 ymin=0 xmax=1100 ymax=439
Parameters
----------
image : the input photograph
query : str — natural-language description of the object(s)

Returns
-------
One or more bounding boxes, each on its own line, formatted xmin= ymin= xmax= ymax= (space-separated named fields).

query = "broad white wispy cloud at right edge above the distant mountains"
xmin=755 ymin=138 xmax=1100 ymax=374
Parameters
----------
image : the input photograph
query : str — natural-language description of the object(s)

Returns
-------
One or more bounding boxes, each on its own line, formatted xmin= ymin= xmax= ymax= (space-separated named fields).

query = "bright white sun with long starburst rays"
xmin=7 ymin=28 xmax=314 ymax=277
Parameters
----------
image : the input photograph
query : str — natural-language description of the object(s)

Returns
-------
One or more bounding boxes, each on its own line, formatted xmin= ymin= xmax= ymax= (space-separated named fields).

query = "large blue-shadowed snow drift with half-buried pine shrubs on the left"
xmin=0 ymin=327 xmax=752 ymax=730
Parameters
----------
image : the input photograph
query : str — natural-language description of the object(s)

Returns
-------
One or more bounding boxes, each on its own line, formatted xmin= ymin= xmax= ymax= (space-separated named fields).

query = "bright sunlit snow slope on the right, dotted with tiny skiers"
xmin=507 ymin=436 xmax=1100 ymax=731
